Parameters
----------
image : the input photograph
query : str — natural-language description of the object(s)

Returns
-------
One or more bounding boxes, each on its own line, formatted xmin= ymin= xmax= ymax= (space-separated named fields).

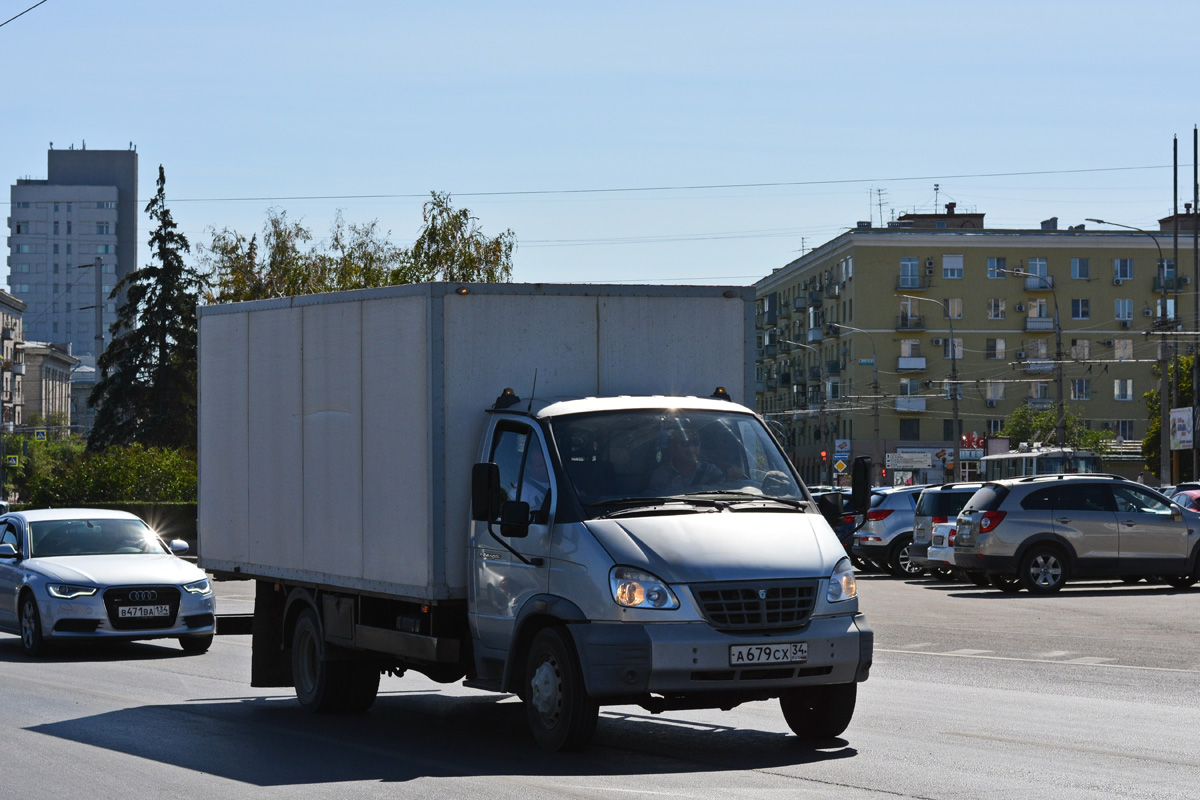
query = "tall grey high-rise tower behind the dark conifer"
xmin=8 ymin=144 xmax=140 ymax=363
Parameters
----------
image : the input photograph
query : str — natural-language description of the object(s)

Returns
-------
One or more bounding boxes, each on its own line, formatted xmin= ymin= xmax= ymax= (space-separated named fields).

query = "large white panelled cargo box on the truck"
xmin=198 ymin=283 xmax=754 ymax=601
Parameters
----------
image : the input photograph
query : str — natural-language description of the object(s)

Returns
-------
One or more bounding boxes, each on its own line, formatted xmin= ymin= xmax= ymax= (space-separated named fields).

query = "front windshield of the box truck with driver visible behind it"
xmin=550 ymin=409 xmax=806 ymax=506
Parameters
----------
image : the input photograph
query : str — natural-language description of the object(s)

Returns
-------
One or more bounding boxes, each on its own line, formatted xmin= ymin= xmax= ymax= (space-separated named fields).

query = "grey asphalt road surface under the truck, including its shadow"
xmin=0 ymin=576 xmax=1200 ymax=800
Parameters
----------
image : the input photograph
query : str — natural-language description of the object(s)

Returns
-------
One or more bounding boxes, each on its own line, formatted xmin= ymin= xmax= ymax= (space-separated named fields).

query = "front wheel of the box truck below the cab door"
xmin=522 ymin=627 xmax=600 ymax=752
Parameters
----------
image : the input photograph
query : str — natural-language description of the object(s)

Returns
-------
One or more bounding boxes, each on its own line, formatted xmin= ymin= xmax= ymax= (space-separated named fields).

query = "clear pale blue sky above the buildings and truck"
xmin=0 ymin=0 xmax=1200 ymax=283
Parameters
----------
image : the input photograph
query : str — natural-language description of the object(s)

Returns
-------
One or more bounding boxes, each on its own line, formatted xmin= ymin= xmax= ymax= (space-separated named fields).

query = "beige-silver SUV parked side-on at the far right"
xmin=954 ymin=475 xmax=1200 ymax=594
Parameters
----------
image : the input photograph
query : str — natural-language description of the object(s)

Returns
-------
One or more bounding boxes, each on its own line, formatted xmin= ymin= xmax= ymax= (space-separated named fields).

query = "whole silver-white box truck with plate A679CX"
xmin=198 ymin=283 xmax=872 ymax=750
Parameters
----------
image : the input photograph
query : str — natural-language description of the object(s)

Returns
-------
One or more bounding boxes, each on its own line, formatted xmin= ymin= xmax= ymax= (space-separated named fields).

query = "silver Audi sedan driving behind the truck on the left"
xmin=0 ymin=509 xmax=216 ymax=656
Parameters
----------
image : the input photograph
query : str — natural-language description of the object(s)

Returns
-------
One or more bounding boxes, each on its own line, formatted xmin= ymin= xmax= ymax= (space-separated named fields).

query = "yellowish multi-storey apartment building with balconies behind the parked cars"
xmin=756 ymin=203 xmax=1195 ymax=483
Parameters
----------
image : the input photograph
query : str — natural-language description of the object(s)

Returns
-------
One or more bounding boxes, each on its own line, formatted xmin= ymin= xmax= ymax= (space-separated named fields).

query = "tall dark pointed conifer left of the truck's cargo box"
xmin=88 ymin=166 xmax=204 ymax=450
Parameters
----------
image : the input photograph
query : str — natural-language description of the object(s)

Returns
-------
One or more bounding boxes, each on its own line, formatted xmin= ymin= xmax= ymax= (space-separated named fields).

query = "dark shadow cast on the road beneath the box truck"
xmin=29 ymin=691 xmax=857 ymax=787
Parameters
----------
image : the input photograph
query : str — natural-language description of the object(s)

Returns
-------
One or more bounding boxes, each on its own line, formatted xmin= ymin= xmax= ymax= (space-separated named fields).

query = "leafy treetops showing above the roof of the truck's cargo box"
xmin=200 ymin=192 xmax=516 ymax=302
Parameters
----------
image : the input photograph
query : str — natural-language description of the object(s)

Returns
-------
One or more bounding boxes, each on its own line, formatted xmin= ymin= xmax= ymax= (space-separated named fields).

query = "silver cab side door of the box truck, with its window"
xmin=470 ymin=420 xmax=557 ymax=657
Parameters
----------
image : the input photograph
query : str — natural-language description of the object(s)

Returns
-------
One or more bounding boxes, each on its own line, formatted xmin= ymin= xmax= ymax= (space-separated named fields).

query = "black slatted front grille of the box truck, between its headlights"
xmin=692 ymin=581 xmax=818 ymax=631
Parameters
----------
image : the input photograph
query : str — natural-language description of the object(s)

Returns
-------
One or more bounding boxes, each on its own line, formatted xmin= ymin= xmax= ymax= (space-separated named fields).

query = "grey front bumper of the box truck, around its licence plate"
xmin=569 ymin=614 xmax=875 ymax=700
